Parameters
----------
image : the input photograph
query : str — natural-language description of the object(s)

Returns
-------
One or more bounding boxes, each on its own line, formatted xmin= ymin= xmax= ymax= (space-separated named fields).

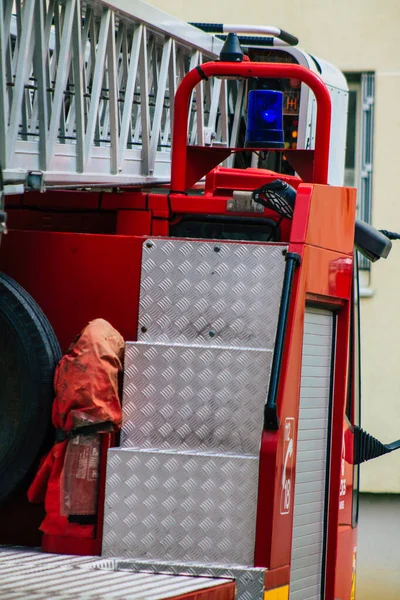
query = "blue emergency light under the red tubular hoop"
xmin=245 ymin=90 xmax=285 ymax=148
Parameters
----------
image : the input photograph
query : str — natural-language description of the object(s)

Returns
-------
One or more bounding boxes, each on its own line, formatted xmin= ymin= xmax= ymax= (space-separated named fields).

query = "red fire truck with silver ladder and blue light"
xmin=0 ymin=0 xmax=399 ymax=600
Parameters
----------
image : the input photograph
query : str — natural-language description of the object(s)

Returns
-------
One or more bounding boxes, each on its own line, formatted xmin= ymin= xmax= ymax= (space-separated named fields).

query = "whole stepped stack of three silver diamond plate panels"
xmin=103 ymin=239 xmax=286 ymax=568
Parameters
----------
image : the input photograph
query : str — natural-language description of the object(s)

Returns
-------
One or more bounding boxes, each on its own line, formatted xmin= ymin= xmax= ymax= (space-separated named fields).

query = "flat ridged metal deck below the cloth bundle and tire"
xmin=0 ymin=548 xmax=233 ymax=600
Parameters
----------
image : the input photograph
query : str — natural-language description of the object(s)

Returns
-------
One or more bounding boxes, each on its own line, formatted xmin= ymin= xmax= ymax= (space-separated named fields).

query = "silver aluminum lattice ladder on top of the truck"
xmin=0 ymin=0 xmax=234 ymax=187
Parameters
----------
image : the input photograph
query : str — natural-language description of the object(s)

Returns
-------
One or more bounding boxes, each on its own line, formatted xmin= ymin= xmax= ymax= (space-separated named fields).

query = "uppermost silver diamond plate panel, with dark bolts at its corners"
xmin=138 ymin=239 xmax=286 ymax=349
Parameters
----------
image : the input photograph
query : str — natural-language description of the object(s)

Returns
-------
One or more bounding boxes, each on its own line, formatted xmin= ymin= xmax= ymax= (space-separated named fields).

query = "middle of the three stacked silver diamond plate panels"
xmin=121 ymin=343 xmax=272 ymax=457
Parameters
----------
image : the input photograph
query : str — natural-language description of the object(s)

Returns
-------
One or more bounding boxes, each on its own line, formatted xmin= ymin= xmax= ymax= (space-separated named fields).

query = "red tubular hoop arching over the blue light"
xmin=171 ymin=62 xmax=331 ymax=193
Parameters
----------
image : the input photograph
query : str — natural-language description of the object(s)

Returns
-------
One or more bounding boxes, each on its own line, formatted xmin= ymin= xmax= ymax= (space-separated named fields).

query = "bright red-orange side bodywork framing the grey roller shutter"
xmin=255 ymin=185 xmax=355 ymax=600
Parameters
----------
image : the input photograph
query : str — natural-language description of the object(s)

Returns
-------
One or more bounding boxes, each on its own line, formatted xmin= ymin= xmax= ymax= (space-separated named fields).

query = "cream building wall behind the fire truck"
xmin=150 ymin=0 xmax=400 ymax=492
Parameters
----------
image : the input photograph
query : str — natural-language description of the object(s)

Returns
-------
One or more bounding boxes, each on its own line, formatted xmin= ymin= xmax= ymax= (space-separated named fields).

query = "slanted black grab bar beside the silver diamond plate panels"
xmin=264 ymin=252 xmax=301 ymax=431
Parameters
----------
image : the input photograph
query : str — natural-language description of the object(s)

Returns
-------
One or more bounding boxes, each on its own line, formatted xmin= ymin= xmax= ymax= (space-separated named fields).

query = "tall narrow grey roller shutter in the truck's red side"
xmin=290 ymin=308 xmax=334 ymax=600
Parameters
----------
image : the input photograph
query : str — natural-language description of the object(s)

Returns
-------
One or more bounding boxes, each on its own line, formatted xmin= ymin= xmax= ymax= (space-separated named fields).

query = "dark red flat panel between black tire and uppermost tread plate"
xmin=0 ymin=231 xmax=144 ymax=350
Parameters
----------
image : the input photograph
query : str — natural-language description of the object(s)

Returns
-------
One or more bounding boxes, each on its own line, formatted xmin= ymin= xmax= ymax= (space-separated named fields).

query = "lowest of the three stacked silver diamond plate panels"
xmin=103 ymin=448 xmax=259 ymax=566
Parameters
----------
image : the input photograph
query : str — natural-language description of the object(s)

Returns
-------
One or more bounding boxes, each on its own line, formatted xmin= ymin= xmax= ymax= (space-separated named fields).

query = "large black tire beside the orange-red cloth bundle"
xmin=0 ymin=274 xmax=61 ymax=503
